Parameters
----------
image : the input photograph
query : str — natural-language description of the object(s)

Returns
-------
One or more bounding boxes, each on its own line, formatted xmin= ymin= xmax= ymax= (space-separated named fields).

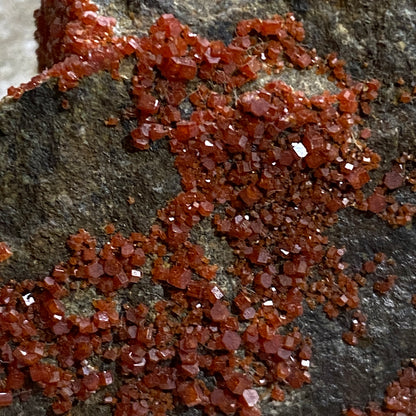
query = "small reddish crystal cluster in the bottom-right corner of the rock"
xmin=344 ymin=360 xmax=416 ymax=416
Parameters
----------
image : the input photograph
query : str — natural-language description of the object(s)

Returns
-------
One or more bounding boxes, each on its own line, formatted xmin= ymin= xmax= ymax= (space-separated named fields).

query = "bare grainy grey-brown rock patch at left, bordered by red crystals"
xmin=0 ymin=73 xmax=180 ymax=279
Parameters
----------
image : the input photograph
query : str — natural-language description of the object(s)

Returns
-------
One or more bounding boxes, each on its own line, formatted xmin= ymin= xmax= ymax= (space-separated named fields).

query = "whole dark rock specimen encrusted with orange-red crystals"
xmin=0 ymin=0 xmax=416 ymax=415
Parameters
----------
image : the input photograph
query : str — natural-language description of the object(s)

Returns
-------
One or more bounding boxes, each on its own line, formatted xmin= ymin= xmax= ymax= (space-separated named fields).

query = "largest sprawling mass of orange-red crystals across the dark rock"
xmin=0 ymin=0 xmax=414 ymax=416
